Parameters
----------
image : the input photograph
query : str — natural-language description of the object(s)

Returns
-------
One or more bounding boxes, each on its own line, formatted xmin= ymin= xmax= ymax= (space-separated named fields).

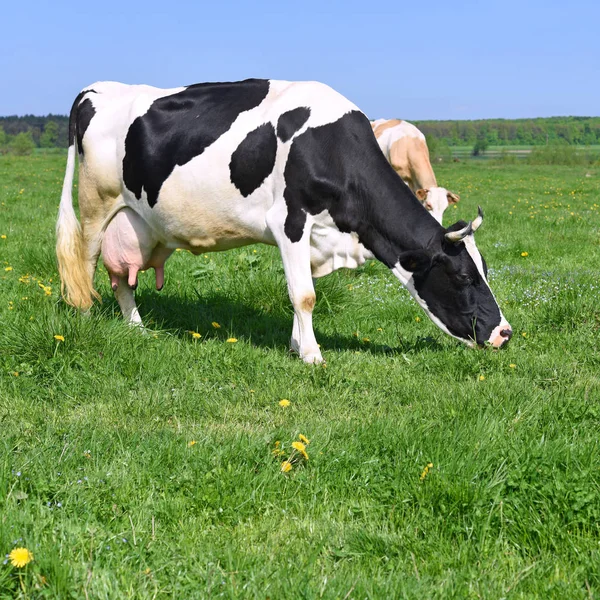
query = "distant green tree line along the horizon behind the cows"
xmin=0 ymin=115 xmax=600 ymax=154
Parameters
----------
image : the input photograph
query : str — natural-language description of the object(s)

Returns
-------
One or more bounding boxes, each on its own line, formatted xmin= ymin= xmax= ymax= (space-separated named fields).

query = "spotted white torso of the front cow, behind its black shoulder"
xmin=75 ymin=79 xmax=357 ymax=252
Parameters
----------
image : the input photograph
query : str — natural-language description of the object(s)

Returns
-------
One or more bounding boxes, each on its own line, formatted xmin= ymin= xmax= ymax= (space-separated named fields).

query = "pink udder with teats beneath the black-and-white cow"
xmin=102 ymin=208 xmax=173 ymax=291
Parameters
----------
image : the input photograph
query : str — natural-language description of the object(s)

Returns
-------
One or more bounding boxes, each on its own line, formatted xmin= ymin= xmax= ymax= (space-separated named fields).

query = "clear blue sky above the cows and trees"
xmin=0 ymin=0 xmax=600 ymax=120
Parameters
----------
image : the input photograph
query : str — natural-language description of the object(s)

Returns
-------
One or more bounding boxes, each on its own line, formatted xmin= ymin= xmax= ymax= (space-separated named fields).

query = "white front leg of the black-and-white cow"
xmin=267 ymin=209 xmax=323 ymax=363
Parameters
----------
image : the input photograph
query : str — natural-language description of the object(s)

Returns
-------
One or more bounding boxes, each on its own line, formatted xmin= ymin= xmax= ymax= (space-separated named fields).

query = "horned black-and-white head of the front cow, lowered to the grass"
xmin=393 ymin=208 xmax=512 ymax=348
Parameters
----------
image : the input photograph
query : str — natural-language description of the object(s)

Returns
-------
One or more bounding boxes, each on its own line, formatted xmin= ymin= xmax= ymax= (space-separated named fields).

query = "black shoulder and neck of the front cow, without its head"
xmin=284 ymin=111 xmax=426 ymax=267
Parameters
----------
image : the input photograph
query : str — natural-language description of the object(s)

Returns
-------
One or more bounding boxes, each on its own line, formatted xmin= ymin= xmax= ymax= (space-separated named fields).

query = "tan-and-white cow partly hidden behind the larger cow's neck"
xmin=371 ymin=119 xmax=460 ymax=225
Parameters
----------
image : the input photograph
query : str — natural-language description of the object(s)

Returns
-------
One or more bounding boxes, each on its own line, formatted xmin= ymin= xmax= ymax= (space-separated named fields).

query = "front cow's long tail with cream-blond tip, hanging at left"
xmin=56 ymin=92 xmax=99 ymax=310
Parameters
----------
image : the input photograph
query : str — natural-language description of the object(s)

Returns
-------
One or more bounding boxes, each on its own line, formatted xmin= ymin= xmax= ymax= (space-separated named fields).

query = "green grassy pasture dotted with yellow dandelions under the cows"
xmin=0 ymin=154 xmax=600 ymax=600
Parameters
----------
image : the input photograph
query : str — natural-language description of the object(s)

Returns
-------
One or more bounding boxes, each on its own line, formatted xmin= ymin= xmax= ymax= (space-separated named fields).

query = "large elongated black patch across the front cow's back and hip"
xmin=123 ymin=79 xmax=269 ymax=207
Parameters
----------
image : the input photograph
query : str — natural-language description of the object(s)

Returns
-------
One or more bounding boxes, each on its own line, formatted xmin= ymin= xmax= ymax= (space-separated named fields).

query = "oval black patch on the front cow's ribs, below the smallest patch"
xmin=229 ymin=123 xmax=277 ymax=197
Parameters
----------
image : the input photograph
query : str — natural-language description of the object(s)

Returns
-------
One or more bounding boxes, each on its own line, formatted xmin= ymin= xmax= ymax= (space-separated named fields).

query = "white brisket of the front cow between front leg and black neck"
xmin=310 ymin=210 xmax=374 ymax=278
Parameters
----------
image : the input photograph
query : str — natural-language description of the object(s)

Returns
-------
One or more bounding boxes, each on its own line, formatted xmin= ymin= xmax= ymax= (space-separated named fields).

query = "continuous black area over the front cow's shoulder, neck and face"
xmin=284 ymin=111 xmax=500 ymax=343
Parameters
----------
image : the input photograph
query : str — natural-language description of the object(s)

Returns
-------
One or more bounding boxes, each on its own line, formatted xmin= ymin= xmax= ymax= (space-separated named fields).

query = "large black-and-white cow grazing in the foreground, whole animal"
xmin=57 ymin=79 xmax=512 ymax=363
